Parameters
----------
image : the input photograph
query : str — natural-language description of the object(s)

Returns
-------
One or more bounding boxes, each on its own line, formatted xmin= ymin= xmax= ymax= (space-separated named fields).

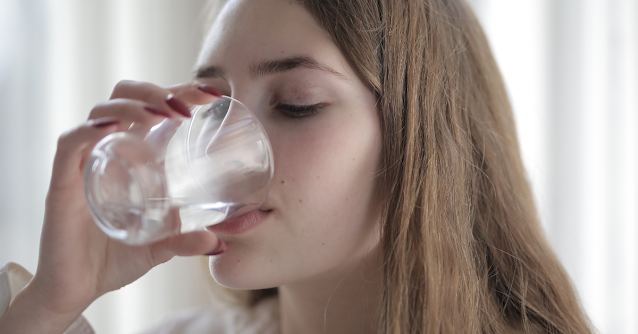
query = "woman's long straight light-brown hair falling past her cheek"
xmin=209 ymin=0 xmax=592 ymax=334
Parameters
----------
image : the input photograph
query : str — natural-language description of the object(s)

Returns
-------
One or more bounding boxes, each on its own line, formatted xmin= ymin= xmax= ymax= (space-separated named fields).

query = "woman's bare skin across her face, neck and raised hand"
xmin=0 ymin=0 xmax=381 ymax=333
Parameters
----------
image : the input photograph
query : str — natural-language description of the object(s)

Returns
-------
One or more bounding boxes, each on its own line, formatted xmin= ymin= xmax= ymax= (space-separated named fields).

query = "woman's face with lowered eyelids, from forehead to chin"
xmin=197 ymin=0 xmax=381 ymax=289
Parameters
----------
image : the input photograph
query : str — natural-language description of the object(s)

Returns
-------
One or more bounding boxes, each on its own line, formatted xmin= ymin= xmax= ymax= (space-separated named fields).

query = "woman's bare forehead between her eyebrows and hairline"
xmin=198 ymin=0 xmax=349 ymax=81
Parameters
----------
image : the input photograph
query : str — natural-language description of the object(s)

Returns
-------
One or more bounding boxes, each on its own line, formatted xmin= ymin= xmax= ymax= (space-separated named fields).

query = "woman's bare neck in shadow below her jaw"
xmin=279 ymin=249 xmax=382 ymax=334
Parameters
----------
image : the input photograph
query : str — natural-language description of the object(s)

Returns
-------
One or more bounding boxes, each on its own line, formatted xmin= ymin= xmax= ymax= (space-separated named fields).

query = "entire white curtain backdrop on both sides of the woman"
xmin=0 ymin=0 xmax=638 ymax=334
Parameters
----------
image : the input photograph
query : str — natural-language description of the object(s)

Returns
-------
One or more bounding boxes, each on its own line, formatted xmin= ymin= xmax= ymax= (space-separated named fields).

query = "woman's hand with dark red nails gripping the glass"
xmin=0 ymin=81 xmax=225 ymax=332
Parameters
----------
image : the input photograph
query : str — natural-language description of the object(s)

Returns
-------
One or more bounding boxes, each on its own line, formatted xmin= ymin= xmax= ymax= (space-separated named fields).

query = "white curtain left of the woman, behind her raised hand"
xmin=0 ymin=0 xmax=218 ymax=334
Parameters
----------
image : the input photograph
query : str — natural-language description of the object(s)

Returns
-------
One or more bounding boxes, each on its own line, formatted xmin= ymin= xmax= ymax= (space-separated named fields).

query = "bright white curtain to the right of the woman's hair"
xmin=471 ymin=0 xmax=638 ymax=333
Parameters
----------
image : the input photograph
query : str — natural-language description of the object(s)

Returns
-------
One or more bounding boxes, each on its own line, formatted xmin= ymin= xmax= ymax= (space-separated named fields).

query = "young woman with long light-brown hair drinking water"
xmin=0 ymin=0 xmax=592 ymax=333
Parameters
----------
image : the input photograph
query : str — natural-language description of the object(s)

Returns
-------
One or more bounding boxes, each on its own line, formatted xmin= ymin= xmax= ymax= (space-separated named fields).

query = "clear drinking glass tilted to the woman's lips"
xmin=84 ymin=96 xmax=273 ymax=245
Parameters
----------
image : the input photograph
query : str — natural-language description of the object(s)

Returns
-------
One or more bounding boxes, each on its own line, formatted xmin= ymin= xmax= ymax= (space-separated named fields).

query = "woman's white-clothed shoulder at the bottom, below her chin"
xmin=140 ymin=297 xmax=279 ymax=334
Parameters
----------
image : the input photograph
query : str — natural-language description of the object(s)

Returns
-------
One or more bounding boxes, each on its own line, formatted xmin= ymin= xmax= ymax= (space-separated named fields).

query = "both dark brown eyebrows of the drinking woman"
xmin=195 ymin=56 xmax=349 ymax=81
